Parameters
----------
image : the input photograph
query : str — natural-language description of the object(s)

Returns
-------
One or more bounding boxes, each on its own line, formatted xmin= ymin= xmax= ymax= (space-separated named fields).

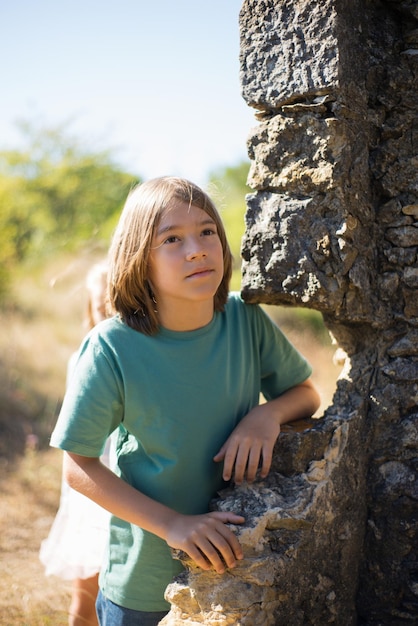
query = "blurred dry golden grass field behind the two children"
xmin=0 ymin=253 xmax=340 ymax=626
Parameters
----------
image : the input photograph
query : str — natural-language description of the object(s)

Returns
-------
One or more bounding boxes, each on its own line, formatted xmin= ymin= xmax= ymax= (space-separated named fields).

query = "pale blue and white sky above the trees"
xmin=0 ymin=0 xmax=255 ymax=184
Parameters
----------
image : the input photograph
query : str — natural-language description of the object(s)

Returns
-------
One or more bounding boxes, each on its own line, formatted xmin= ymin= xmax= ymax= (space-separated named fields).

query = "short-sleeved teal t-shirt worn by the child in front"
xmin=51 ymin=294 xmax=311 ymax=611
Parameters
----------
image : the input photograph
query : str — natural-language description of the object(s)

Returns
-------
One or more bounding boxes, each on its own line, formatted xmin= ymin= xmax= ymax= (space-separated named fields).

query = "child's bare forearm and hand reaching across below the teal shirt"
xmin=64 ymin=452 xmax=244 ymax=574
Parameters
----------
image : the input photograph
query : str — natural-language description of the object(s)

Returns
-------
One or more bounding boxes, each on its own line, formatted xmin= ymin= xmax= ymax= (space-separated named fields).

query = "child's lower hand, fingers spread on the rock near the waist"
xmin=166 ymin=511 xmax=244 ymax=574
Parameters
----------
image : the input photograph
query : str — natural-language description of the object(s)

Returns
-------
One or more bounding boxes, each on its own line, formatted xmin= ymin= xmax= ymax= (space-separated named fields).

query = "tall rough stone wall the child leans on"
xmin=162 ymin=0 xmax=418 ymax=626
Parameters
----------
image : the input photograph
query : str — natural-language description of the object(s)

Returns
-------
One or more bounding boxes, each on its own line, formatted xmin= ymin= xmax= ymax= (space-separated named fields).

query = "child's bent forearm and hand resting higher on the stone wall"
xmin=214 ymin=378 xmax=320 ymax=485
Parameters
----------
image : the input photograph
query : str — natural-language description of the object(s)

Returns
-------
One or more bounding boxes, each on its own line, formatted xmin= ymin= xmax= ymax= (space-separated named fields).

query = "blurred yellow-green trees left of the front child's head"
xmin=0 ymin=122 xmax=138 ymax=293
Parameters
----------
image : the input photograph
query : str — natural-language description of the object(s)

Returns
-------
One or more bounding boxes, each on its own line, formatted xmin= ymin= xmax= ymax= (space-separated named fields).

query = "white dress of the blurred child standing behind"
xmin=39 ymin=355 xmax=111 ymax=580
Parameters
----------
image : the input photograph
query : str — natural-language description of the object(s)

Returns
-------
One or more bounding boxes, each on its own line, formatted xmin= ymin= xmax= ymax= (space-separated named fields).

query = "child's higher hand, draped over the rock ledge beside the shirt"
xmin=213 ymin=404 xmax=280 ymax=485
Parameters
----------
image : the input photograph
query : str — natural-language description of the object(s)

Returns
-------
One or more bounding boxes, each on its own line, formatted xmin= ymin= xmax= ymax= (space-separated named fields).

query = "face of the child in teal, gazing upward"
xmin=149 ymin=201 xmax=224 ymax=324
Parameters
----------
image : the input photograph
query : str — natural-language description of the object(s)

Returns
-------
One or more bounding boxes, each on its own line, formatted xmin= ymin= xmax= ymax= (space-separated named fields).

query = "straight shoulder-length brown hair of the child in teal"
xmin=109 ymin=176 xmax=232 ymax=335
